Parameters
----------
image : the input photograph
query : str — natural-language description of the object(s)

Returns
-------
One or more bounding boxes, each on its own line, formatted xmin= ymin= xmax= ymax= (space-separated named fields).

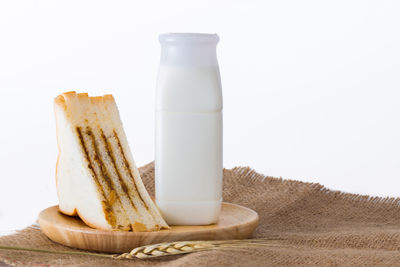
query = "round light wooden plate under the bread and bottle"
xmin=38 ymin=203 xmax=258 ymax=253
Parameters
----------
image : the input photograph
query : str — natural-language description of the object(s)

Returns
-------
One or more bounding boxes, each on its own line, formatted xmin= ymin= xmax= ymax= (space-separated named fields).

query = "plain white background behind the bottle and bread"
xmin=0 ymin=0 xmax=400 ymax=231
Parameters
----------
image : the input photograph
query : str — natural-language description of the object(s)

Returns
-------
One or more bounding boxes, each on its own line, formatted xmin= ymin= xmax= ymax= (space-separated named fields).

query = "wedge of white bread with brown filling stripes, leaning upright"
xmin=54 ymin=92 xmax=169 ymax=231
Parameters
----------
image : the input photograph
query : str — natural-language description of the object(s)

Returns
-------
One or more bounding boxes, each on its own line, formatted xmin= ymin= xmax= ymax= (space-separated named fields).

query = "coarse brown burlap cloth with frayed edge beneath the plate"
xmin=0 ymin=164 xmax=400 ymax=266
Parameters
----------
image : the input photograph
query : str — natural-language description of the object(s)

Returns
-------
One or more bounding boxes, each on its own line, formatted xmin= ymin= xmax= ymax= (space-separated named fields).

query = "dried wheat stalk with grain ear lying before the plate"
xmin=0 ymin=239 xmax=277 ymax=259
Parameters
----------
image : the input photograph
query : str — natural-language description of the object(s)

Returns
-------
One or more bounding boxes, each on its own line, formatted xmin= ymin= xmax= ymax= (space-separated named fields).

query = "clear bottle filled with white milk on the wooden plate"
xmin=155 ymin=33 xmax=222 ymax=225
